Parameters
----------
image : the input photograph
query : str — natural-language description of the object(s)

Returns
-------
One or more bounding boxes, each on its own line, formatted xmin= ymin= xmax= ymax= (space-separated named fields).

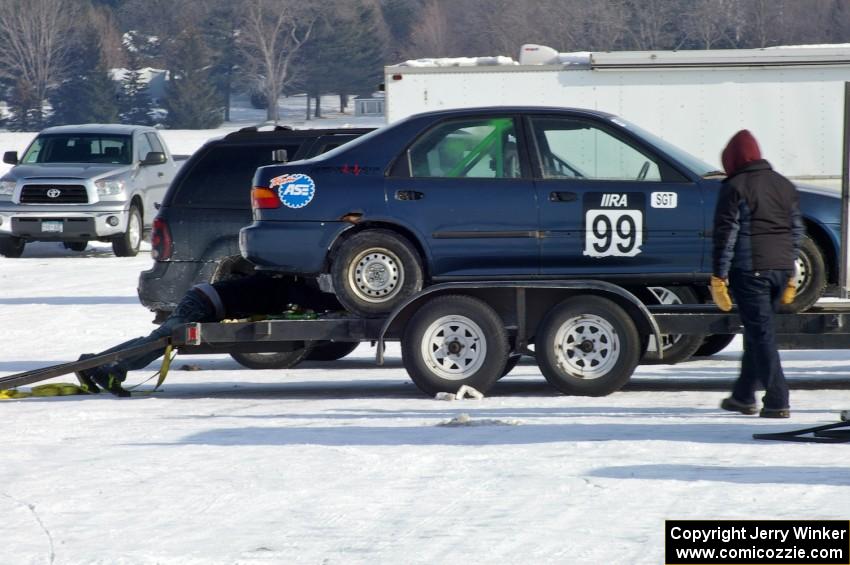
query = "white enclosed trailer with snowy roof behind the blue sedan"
xmin=385 ymin=45 xmax=850 ymax=187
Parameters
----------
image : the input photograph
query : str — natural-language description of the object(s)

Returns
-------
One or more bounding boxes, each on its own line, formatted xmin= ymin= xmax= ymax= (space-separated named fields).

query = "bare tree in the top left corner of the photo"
xmin=0 ymin=0 xmax=77 ymax=122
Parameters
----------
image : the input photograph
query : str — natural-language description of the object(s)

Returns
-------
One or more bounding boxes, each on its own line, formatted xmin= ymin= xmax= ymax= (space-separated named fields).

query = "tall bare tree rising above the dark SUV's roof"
xmin=240 ymin=0 xmax=317 ymax=123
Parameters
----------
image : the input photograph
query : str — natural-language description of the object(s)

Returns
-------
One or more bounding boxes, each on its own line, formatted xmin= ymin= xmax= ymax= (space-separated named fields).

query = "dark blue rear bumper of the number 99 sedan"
xmin=239 ymin=221 xmax=352 ymax=275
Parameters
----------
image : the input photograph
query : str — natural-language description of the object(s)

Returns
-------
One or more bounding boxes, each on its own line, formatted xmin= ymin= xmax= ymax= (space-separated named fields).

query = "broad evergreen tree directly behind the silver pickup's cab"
xmin=50 ymin=37 xmax=118 ymax=124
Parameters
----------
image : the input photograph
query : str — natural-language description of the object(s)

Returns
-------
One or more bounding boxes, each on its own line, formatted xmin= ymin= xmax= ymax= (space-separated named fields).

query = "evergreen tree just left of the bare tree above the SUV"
xmin=164 ymin=28 xmax=222 ymax=129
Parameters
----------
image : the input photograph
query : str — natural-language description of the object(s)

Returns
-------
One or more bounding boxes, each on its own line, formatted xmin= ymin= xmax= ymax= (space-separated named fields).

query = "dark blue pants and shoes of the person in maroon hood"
xmin=729 ymin=270 xmax=791 ymax=409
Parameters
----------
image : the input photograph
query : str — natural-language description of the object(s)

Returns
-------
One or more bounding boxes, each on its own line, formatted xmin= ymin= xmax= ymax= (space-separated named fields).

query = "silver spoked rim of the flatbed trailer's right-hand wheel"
xmin=554 ymin=314 xmax=620 ymax=380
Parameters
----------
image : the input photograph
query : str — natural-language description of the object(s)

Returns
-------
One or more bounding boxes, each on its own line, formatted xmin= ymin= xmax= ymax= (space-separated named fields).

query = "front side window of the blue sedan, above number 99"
xmin=531 ymin=117 xmax=662 ymax=181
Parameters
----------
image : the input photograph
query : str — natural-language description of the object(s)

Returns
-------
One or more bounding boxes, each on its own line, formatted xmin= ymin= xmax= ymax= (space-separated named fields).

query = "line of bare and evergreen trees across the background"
xmin=0 ymin=0 xmax=850 ymax=130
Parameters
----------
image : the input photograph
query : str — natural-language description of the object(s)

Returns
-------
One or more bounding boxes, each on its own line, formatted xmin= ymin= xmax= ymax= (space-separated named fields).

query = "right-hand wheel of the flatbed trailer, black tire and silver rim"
xmin=535 ymin=296 xmax=642 ymax=396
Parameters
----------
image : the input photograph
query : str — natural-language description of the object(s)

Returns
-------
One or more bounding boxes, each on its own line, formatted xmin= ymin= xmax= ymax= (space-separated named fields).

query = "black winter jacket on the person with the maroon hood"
xmin=713 ymin=159 xmax=805 ymax=278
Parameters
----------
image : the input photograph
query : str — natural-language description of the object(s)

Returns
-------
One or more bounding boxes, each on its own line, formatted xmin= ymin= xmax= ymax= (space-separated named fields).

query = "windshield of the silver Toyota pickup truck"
xmin=21 ymin=133 xmax=133 ymax=165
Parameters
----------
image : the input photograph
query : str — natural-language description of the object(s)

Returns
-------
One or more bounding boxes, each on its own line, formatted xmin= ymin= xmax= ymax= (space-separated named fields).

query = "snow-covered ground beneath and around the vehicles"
xmin=0 ymin=243 xmax=850 ymax=565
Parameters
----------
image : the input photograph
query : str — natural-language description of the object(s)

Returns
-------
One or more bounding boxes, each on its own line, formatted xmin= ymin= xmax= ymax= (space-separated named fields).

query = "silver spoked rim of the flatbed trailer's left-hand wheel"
xmin=421 ymin=315 xmax=487 ymax=381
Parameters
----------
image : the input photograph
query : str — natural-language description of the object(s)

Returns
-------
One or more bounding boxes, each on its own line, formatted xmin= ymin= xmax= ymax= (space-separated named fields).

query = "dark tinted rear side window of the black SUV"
xmin=174 ymin=143 xmax=299 ymax=209
